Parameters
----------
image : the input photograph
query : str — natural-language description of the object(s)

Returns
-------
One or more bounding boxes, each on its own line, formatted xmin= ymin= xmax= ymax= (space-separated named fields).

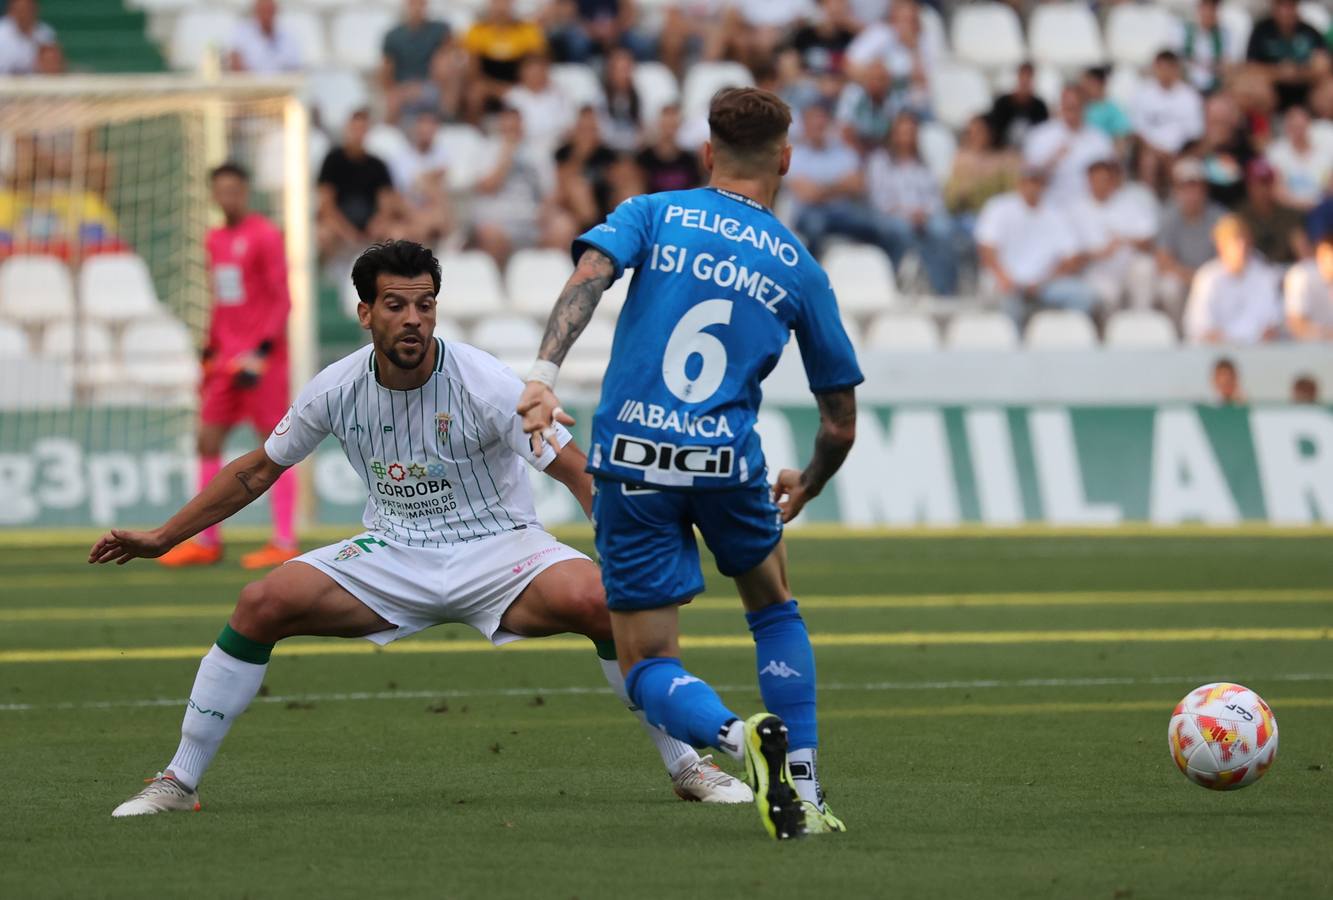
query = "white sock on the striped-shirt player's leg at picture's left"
xmin=165 ymin=644 xmax=268 ymax=789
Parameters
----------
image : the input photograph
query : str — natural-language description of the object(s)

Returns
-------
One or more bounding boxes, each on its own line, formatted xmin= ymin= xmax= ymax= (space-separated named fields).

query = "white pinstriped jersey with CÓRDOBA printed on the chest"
xmin=264 ymin=337 xmax=571 ymax=547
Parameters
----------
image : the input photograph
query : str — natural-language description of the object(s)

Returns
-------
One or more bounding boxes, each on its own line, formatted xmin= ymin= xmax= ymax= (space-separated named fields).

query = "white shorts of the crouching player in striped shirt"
xmin=292 ymin=527 xmax=588 ymax=647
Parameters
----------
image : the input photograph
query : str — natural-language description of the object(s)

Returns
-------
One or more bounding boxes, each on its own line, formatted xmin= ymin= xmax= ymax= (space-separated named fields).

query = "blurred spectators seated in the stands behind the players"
xmin=0 ymin=0 xmax=1333 ymax=344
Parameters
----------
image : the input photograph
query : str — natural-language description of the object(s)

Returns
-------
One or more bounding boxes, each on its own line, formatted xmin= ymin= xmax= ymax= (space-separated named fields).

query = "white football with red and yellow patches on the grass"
xmin=1166 ymin=681 xmax=1277 ymax=791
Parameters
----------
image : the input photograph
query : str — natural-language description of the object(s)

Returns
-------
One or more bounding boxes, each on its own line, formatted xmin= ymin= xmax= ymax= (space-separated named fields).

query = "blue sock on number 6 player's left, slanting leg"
xmin=625 ymin=656 xmax=740 ymax=747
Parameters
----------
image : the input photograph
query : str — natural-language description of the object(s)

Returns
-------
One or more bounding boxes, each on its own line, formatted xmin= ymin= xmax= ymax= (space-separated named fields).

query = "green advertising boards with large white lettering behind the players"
xmin=0 ymin=405 xmax=1333 ymax=531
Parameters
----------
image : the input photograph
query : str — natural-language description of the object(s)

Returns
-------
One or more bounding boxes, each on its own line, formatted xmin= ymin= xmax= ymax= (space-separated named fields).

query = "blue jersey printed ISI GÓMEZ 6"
xmin=573 ymin=188 xmax=864 ymax=491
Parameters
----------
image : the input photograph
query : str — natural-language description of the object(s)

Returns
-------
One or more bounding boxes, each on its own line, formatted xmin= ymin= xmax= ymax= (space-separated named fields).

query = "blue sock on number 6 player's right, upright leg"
xmin=745 ymin=600 xmax=820 ymax=751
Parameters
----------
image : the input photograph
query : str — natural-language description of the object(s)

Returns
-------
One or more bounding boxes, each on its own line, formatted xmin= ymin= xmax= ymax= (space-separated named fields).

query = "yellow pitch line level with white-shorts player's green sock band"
xmin=0 ymin=628 xmax=1333 ymax=663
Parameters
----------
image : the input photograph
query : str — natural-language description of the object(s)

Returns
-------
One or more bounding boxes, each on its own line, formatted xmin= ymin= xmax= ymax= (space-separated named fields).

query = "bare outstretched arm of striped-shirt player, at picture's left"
xmin=88 ymin=448 xmax=287 ymax=565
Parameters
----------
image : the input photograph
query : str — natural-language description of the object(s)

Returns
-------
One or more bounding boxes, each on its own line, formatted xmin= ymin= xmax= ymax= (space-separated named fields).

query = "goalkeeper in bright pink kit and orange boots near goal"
xmin=159 ymin=164 xmax=300 ymax=569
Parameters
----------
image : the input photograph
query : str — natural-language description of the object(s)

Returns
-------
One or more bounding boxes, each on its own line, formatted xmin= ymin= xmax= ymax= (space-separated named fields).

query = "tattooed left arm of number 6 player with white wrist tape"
xmin=519 ymin=247 xmax=616 ymax=453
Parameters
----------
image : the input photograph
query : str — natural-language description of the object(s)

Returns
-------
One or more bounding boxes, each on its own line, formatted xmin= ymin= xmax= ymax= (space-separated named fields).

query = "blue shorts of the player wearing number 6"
xmin=592 ymin=479 xmax=782 ymax=609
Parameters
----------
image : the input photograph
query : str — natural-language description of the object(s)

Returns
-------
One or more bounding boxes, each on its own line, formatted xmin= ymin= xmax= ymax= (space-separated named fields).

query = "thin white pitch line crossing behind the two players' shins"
xmin=0 ymin=672 xmax=1333 ymax=712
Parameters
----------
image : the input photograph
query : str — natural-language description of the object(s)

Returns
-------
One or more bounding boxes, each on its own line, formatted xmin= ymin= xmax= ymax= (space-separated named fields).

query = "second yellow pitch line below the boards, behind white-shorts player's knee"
xmin=0 ymin=588 xmax=1333 ymax=623
